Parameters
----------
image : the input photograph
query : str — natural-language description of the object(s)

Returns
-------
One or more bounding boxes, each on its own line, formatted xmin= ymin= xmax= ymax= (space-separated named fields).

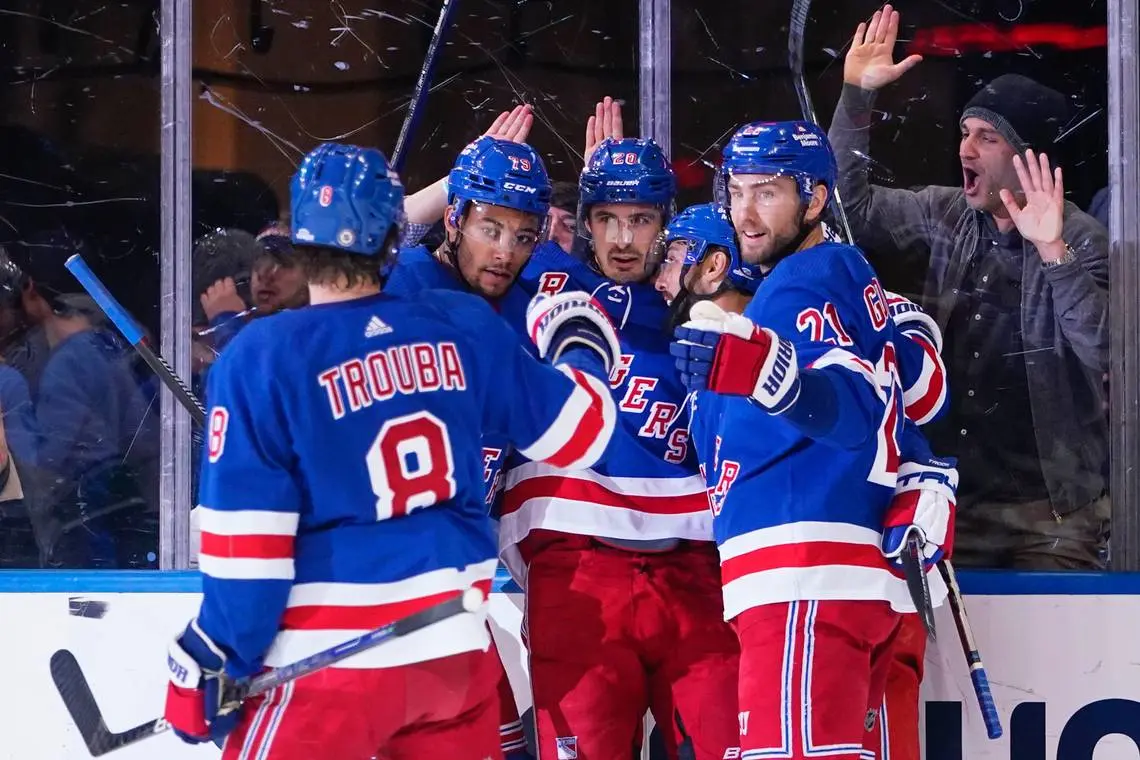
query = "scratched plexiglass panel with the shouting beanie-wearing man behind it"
xmin=671 ymin=0 xmax=1109 ymax=570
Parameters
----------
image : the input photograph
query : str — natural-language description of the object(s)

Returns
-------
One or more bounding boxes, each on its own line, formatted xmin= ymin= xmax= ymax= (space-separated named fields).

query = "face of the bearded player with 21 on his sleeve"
xmin=728 ymin=174 xmax=804 ymax=265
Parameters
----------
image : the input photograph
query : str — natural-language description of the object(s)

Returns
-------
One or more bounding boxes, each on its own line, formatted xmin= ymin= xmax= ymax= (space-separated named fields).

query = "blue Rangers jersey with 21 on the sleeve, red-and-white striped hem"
xmin=691 ymin=243 xmax=913 ymax=619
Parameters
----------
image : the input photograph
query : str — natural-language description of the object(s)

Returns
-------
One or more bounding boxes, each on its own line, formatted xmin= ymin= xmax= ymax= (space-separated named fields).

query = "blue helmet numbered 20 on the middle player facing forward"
xmin=578 ymin=137 xmax=677 ymax=216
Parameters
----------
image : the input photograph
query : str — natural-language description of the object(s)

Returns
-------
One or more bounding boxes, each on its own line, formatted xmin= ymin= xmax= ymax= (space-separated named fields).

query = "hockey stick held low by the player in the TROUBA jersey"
xmin=51 ymin=587 xmax=486 ymax=758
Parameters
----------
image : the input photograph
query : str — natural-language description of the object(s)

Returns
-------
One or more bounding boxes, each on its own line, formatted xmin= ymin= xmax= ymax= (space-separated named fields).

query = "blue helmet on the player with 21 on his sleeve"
xmin=713 ymin=121 xmax=839 ymax=207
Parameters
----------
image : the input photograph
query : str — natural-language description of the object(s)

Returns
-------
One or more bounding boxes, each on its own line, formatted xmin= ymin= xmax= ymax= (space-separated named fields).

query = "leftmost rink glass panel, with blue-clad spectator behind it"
xmin=0 ymin=0 xmax=161 ymax=569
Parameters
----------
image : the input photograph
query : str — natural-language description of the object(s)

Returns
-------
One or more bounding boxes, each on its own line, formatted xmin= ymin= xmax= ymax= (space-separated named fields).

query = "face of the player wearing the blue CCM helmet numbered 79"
xmin=456 ymin=203 xmax=542 ymax=299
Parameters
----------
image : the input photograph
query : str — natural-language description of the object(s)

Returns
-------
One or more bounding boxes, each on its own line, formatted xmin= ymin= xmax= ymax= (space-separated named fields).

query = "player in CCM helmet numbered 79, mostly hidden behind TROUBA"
xmin=384 ymin=136 xmax=551 ymax=760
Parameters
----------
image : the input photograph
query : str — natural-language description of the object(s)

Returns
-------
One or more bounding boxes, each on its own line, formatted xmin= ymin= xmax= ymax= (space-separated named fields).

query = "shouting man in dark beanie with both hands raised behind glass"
xmin=829 ymin=5 xmax=1109 ymax=570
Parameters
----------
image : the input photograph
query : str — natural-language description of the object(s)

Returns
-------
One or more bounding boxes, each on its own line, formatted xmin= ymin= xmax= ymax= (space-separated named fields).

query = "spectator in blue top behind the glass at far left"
xmin=5 ymin=231 xmax=158 ymax=569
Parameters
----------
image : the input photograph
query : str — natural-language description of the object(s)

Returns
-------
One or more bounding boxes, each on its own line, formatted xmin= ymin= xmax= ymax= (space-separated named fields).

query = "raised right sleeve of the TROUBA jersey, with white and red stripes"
xmin=449 ymin=300 xmax=617 ymax=469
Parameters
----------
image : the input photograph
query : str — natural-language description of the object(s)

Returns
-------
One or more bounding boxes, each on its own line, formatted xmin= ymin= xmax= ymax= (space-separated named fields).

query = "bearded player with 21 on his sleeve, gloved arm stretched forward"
xmin=674 ymin=122 xmax=956 ymax=759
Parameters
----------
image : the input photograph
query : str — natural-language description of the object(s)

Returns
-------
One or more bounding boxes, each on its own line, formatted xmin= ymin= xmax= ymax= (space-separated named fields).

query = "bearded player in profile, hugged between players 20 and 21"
xmin=656 ymin=204 xmax=946 ymax=760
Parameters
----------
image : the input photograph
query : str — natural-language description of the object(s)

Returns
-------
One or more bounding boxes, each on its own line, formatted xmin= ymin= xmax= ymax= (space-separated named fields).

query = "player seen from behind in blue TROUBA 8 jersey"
xmin=165 ymin=145 xmax=618 ymax=760
